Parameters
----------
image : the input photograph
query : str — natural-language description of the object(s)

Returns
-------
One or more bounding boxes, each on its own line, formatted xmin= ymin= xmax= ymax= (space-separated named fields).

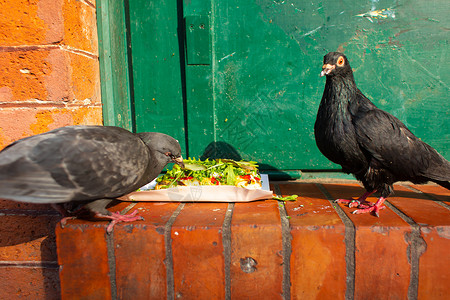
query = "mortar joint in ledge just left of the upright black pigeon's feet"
xmin=315 ymin=183 xmax=356 ymax=299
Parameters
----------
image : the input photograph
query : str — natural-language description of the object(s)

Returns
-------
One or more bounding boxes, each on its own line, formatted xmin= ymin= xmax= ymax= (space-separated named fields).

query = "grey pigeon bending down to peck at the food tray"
xmin=0 ymin=126 xmax=183 ymax=232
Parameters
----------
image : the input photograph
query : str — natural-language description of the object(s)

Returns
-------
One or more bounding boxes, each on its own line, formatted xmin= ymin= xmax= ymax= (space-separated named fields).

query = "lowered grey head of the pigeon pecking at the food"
xmin=137 ymin=132 xmax=184 ymax=167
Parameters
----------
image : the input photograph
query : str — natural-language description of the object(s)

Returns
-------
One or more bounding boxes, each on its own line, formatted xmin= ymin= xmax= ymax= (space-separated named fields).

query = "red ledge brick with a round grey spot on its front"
xmin=231 ymin=200 xmax=283 ymax=299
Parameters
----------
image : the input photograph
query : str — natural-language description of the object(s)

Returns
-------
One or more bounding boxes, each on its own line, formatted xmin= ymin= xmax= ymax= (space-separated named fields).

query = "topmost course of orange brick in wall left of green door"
xmin=0 ymin=0 xmax=98 ymax=54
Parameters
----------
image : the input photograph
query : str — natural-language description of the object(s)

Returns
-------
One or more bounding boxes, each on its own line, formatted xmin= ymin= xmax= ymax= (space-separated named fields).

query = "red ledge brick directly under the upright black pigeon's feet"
xmin=324 ymin=184 xmax=412 ymax=299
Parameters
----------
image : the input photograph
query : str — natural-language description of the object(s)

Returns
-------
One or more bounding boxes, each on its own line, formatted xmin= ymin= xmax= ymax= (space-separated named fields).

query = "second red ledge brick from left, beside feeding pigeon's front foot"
xmin=114 ymin=203 xmax=178 ymax=299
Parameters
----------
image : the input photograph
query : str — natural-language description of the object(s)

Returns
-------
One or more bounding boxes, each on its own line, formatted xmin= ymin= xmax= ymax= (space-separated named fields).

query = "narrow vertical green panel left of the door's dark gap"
xmin=129 ymin=1 xmax=186 ymax=155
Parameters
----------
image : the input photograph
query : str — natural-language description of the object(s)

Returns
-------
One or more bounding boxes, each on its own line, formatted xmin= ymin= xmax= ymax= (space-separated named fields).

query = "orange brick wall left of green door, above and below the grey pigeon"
xmin=0 ymin=0 xmax=102 ymax=299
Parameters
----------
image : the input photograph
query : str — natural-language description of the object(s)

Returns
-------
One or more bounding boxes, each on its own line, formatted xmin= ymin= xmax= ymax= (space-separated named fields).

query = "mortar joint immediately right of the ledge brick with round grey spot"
xmin=273 ymin=184 xmax=292 ymax=300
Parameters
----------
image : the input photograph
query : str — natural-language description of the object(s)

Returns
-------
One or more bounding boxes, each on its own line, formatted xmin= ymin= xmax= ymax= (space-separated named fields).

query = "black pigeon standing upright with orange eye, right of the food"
xmin=314 ymin=52 xmax=450 ymax=216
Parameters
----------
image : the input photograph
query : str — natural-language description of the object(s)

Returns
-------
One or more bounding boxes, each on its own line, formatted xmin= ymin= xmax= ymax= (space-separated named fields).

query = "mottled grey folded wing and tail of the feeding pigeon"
xmin=0 ymin=127 xmax=149 ymax=203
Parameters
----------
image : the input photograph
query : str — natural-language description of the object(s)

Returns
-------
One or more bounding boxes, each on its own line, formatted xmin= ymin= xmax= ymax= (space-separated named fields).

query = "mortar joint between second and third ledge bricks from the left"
xmin=164 ymin=203 xmax=185 ymax=300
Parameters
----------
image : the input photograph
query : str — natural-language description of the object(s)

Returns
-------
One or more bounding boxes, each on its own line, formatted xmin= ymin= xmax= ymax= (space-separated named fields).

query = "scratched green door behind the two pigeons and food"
xmin=97 ymin=0 xmax=450 ymax=176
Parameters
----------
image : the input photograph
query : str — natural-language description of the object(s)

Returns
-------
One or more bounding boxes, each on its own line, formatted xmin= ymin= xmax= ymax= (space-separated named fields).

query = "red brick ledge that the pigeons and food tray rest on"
xmin=56 ymin=182 xmax=450 ymax=300
